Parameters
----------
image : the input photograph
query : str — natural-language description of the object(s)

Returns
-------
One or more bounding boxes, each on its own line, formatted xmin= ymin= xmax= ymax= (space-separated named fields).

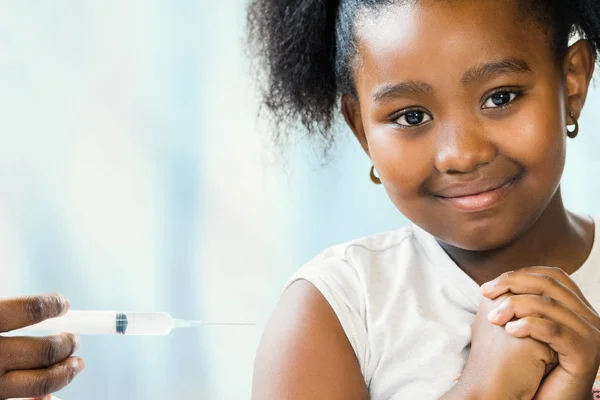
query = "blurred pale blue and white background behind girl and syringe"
xmin=0 ymin=0 xmax=600 ymax=400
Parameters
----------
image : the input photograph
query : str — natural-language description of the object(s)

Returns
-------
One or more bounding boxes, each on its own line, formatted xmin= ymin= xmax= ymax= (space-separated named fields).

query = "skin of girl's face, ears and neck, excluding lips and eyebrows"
xmin=343 ymin=1 xmax=594 ymax=284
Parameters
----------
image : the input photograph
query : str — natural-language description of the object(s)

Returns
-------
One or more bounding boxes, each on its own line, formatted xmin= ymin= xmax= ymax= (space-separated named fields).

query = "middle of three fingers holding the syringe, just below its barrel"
xmin=0 ymin=333 xmax=79 ymax=373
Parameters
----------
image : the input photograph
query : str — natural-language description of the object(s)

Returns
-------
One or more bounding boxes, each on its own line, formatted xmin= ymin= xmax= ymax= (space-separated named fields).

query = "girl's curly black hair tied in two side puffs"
xmin=247 ymin=0 xmax=600 ymax=145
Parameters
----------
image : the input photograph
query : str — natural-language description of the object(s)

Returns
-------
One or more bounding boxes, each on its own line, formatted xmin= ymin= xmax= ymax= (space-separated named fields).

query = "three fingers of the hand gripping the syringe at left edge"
xmin=0 ymin=294 xmax=84 ymax=399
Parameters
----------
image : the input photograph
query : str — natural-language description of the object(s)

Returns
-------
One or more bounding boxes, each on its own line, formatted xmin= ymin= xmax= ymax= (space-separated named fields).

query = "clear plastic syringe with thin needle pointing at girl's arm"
xmin=13 ymin=310 xmax=253 ymax=336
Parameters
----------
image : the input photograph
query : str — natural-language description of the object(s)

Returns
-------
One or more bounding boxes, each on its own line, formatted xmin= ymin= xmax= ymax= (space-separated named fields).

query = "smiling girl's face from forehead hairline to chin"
xmin=343 ymin=0 xmax=585 ymax=250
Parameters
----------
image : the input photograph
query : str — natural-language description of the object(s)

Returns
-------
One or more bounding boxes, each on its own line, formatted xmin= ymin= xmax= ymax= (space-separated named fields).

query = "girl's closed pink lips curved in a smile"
xmin=434 ymin=177 xmax=516 ymax=212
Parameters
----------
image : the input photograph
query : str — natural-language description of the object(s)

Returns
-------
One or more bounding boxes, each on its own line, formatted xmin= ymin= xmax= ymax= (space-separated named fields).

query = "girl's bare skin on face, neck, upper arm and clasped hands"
xmin=253 ymin=0 xmax=600 ymax=400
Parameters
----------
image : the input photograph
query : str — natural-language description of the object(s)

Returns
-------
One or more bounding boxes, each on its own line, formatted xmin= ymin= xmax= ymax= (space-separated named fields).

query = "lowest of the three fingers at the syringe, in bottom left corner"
xmin=0 ymin=357 xmax=84 ymax=399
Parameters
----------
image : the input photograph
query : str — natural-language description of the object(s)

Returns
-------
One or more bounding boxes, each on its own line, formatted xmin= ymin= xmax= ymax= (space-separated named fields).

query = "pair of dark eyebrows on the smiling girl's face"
xmin=373 ymin=58 xmax=531 ymax=102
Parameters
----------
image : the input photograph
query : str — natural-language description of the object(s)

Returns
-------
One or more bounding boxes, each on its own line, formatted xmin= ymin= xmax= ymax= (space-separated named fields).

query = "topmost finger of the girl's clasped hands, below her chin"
xmin=481 ymin=268 xmax=600 ymax=328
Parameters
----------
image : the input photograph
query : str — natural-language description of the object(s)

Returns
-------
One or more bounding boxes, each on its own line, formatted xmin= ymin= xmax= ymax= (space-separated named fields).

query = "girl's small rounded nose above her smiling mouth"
xmin=435 ymin=119 xmax=498 ymax=174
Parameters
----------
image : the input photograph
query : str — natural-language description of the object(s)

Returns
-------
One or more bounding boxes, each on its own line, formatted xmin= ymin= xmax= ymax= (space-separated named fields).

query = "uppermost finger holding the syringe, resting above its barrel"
xmin=0 ymin=294 xmax=69 ymax=332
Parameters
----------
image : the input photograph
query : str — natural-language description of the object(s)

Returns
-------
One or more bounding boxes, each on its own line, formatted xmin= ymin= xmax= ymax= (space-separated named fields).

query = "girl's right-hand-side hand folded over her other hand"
xmin=481 ymin=267 xmax=600 ymax=400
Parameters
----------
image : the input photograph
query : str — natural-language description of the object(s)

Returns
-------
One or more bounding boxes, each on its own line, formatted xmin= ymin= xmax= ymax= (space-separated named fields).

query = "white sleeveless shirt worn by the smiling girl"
xmin=285 ymin=219 xmax=600 ymax=400
